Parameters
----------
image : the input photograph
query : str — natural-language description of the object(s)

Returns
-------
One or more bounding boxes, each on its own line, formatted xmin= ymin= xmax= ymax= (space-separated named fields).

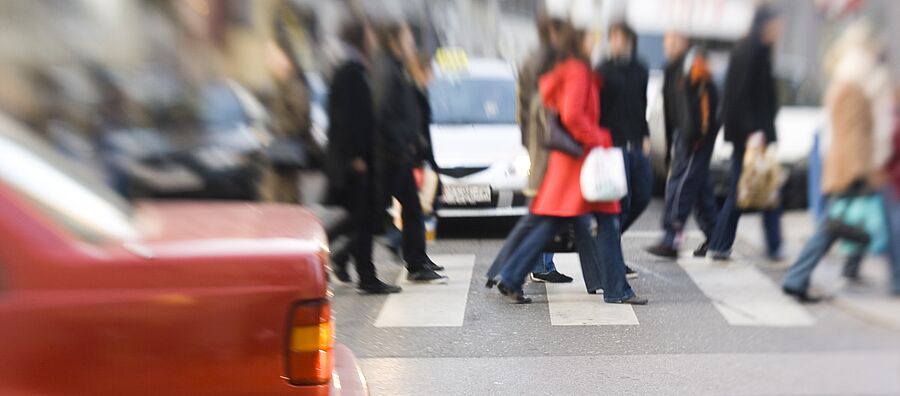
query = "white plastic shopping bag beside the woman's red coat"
xmin=581 ymin=147 xmax=628 ymax=202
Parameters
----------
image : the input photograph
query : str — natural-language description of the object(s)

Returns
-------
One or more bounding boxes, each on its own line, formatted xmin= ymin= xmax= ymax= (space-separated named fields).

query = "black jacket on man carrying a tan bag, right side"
xmin=722 ymin=37 xmax=778 ymax=147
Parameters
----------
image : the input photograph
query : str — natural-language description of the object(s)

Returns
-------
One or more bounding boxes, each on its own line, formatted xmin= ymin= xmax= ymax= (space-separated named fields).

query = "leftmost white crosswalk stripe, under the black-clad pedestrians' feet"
xmin=375 ymin=254 xmax=475 ymax=327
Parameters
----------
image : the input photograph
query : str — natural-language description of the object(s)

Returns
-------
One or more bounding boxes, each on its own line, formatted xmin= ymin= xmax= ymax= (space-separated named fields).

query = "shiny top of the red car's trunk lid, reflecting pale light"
xmin=129 ymin=202 xmax=327 ymax=256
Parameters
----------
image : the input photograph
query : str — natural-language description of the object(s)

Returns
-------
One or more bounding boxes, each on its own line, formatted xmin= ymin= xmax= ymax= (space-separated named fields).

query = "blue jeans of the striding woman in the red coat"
xmin=500 ymin=214 xmax=634 ymax=302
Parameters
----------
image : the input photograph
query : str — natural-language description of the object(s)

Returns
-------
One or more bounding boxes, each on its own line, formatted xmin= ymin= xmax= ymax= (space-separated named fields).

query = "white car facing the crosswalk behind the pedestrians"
xmin=429 ymin=59 xmax=530 ymax=218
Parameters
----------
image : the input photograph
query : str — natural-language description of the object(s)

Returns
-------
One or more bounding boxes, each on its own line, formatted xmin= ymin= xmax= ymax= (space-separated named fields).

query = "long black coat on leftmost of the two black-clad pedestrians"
xmin=326 ymin=60 xmax=375 ymax=195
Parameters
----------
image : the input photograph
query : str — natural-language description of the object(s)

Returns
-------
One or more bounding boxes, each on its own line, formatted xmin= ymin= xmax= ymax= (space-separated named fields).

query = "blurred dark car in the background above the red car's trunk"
xmin=100 ymin=81 xmax=269 ymax=200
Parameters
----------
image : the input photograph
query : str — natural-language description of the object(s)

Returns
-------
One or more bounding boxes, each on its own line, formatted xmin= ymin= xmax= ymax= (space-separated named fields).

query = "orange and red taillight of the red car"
xmin=286 ymin=300 xmax=334 ymax=385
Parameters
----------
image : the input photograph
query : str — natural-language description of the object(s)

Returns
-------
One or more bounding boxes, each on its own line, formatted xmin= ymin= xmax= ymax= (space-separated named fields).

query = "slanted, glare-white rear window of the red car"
xmin=0 ymin=117 xmax=138 ymax=242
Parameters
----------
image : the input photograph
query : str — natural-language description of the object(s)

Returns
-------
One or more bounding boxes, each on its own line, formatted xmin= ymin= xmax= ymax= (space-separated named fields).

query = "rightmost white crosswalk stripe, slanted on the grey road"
xmin=678 ymin=259 xmax=816 ymax=327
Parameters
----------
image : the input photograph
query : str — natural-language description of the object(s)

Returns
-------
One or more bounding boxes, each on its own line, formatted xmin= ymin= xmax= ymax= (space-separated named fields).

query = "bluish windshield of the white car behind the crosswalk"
xmin=429 ymin=78 xmax=516 ymax=124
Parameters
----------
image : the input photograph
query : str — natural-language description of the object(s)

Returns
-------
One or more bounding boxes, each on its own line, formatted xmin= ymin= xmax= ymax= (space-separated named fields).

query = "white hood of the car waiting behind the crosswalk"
xmin=431 ymin=124 xmax=528 ymax=169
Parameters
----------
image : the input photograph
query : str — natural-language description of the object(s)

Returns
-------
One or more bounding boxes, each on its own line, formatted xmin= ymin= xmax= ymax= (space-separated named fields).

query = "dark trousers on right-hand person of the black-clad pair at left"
xmin=387 ymin=165 xmax=428 ymax=273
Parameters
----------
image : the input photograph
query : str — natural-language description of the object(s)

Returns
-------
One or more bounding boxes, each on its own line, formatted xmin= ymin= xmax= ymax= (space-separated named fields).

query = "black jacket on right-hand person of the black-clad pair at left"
xmin=375 ymin=55 xmax=422 ymax=166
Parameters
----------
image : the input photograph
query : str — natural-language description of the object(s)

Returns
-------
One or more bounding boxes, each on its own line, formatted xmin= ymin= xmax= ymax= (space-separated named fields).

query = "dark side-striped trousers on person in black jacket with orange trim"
xmin=662 ymin=135 xmax=717 ymax=246
